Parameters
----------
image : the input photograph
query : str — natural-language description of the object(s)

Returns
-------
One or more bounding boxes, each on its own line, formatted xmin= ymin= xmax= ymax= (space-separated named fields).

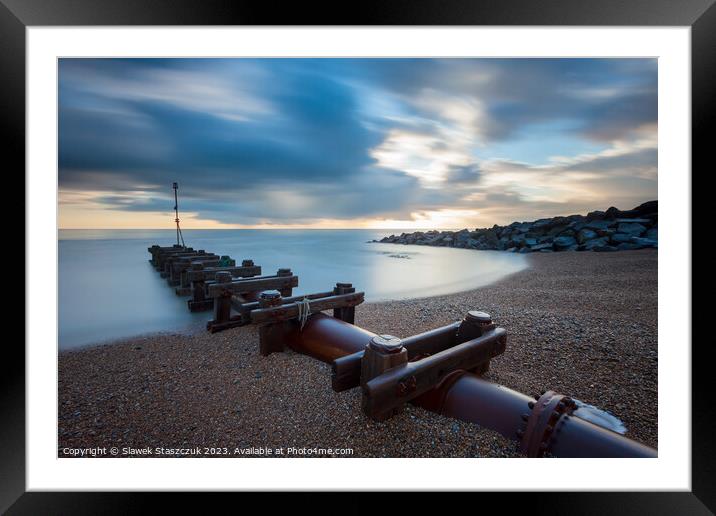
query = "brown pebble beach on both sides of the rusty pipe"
xmin=58 ymin=249 xmax=658 ymax=458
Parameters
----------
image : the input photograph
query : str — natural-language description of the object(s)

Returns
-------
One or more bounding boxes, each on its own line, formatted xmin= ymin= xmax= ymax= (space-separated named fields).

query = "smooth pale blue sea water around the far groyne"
xmin=59 ymin=230 xmax=526 ymax=349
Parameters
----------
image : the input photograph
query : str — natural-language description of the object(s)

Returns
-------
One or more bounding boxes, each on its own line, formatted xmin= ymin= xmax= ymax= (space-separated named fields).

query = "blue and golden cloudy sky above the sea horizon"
xmin=58 ymin=58 xmax=657 ymax=229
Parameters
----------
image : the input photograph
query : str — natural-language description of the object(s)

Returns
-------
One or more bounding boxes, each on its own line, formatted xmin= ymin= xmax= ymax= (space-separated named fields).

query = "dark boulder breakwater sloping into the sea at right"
xmin=373 ymin=201 xmax=658 ymax=253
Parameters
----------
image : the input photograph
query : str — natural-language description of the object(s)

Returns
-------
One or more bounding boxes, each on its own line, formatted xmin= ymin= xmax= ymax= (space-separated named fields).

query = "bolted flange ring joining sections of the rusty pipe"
xmin=518 ymin=391 xmax=577 ymax=457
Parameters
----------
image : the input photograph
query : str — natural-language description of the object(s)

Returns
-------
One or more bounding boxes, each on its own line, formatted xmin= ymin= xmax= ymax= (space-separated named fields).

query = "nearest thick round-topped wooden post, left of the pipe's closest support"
xmin=360 ymin=335 xmax=408 ymax=421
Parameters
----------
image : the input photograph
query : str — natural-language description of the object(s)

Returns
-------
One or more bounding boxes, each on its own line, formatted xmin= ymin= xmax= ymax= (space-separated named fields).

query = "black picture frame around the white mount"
xmin=0 ymin=0 xmax=716 ymax=514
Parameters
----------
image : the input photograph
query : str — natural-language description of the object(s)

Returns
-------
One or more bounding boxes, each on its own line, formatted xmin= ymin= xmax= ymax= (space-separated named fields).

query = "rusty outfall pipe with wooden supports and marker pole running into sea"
xmin=147 ymin=183 xmax=656 ymax=457
